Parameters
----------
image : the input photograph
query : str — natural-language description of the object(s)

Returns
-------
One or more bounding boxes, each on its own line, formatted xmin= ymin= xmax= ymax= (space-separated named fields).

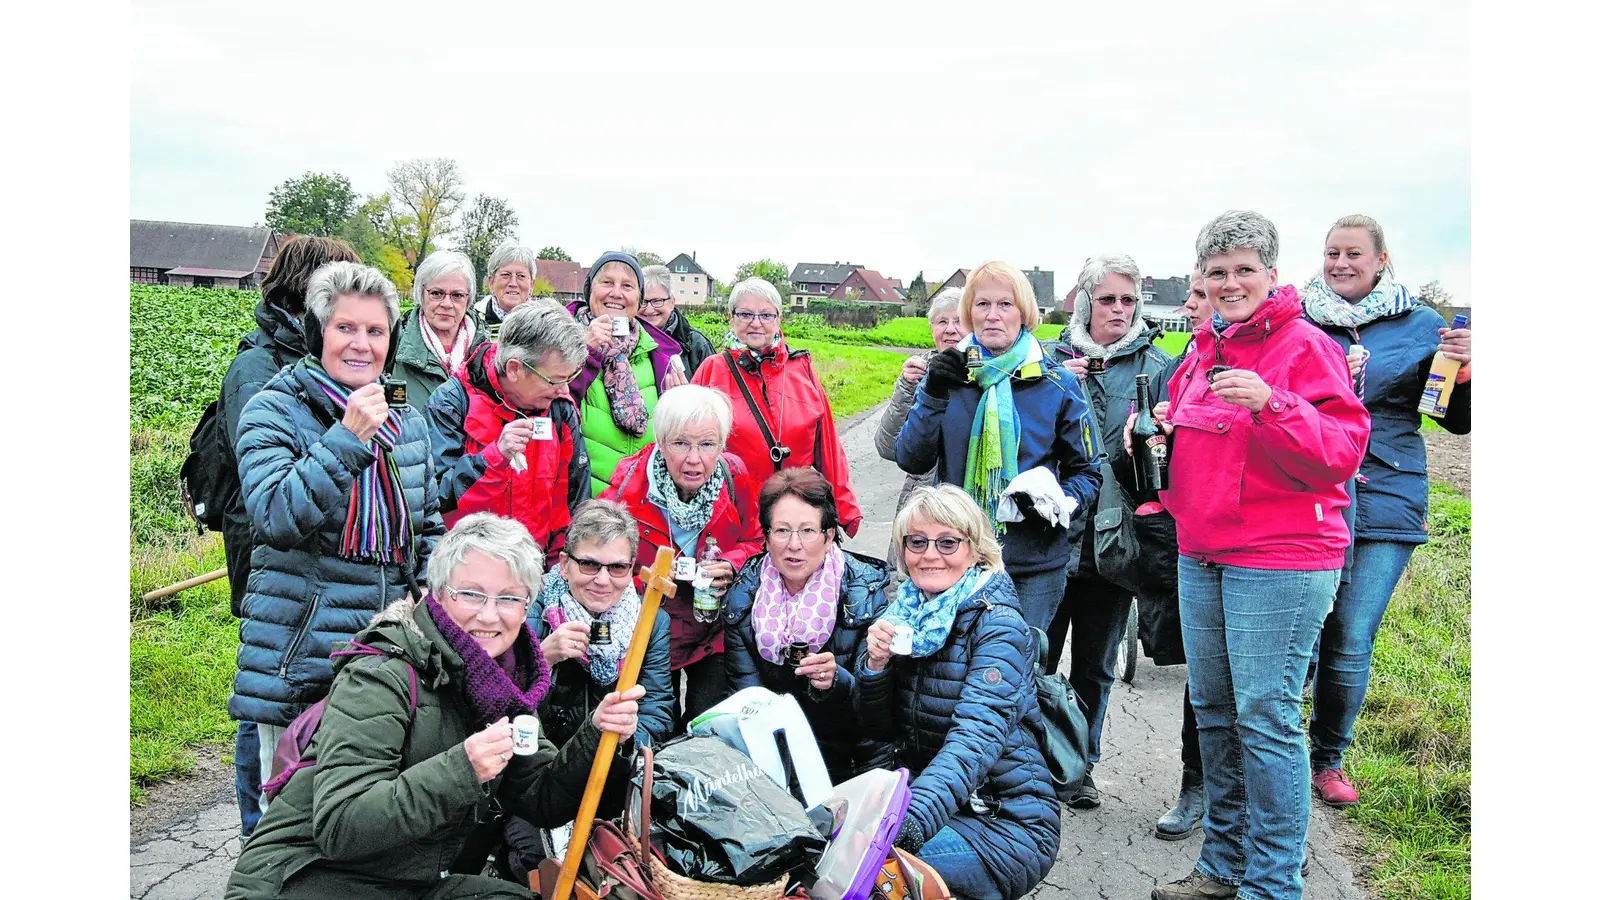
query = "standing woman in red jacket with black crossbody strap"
xmin=694 ymin=279 xmax=861 ymax=536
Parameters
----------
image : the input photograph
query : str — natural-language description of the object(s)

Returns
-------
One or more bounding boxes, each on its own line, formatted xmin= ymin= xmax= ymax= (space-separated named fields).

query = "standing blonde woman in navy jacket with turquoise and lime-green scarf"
xmin=894 ymin=263 xmax=1102 ymax=631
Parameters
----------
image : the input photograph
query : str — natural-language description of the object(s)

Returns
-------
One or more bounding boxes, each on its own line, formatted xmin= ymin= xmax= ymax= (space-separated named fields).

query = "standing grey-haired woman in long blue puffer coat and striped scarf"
xmin=227 ymin=261 xmax=445 ymax=814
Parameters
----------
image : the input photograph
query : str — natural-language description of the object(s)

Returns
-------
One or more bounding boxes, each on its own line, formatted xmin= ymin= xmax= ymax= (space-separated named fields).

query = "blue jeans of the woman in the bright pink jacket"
xmin=1178 ymin=556 xmax=1339 ymax=900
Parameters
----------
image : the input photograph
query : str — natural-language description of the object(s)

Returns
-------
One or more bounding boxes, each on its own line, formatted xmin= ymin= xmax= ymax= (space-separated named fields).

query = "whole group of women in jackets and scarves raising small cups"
xmin=212 ymin=211 xmax=1470 ymax=900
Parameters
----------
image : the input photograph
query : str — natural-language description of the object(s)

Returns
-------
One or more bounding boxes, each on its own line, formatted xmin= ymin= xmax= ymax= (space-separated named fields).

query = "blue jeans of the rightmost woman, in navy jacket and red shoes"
xmin=1310 ymin=541 xmax=1416 ymax=770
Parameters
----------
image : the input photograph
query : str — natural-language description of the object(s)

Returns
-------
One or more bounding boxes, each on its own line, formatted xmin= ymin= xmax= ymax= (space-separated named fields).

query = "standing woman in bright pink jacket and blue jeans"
xmin=1152 ymin=210 xmax=1371 ymax=900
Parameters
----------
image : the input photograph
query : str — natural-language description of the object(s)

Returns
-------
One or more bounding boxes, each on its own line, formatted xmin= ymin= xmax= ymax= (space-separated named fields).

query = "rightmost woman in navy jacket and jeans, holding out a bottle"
xmin=1302 ymin=216 xmax=1472 ymax=806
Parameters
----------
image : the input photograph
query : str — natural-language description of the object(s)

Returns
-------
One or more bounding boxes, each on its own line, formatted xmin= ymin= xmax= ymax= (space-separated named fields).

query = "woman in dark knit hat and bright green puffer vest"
xmin=566 ymin=251 xmax=688 ymax=496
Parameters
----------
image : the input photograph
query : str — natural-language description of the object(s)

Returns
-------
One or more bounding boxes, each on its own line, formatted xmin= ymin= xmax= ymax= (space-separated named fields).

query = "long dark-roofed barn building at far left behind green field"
xmin=128 ymin=219 xmax=286 ymax=290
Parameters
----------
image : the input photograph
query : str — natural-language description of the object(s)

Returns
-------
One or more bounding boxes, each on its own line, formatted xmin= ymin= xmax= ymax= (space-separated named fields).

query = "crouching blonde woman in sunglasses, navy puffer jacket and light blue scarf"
xmin=856 ymin=485 xmax=1061 ymax=900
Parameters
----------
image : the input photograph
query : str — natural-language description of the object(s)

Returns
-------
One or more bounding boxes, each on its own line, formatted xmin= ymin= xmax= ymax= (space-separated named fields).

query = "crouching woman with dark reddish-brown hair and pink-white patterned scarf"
xmin=723 ymin=466 xmax=891 ymax=785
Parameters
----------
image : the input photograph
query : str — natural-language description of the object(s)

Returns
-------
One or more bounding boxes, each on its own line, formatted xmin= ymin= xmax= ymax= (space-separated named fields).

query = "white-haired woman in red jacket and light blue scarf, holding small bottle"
xmin=600 ymin=384 xmax=765 ymax=729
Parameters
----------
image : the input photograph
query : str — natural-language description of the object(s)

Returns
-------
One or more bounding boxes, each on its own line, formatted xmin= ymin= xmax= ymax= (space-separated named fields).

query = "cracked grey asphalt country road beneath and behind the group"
xmin=130 ymin=408 xmax=1363 ymax=900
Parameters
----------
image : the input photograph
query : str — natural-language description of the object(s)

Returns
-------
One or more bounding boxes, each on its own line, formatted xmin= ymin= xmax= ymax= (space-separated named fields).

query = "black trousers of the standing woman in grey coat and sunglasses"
xmin=1046 ymin=575 xmax=1133 ymax=765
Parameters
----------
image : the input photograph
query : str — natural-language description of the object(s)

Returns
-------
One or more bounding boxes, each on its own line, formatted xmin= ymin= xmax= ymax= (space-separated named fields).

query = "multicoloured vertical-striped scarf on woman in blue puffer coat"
xmin=306 ymin=358 xmax=409 ymax=565
